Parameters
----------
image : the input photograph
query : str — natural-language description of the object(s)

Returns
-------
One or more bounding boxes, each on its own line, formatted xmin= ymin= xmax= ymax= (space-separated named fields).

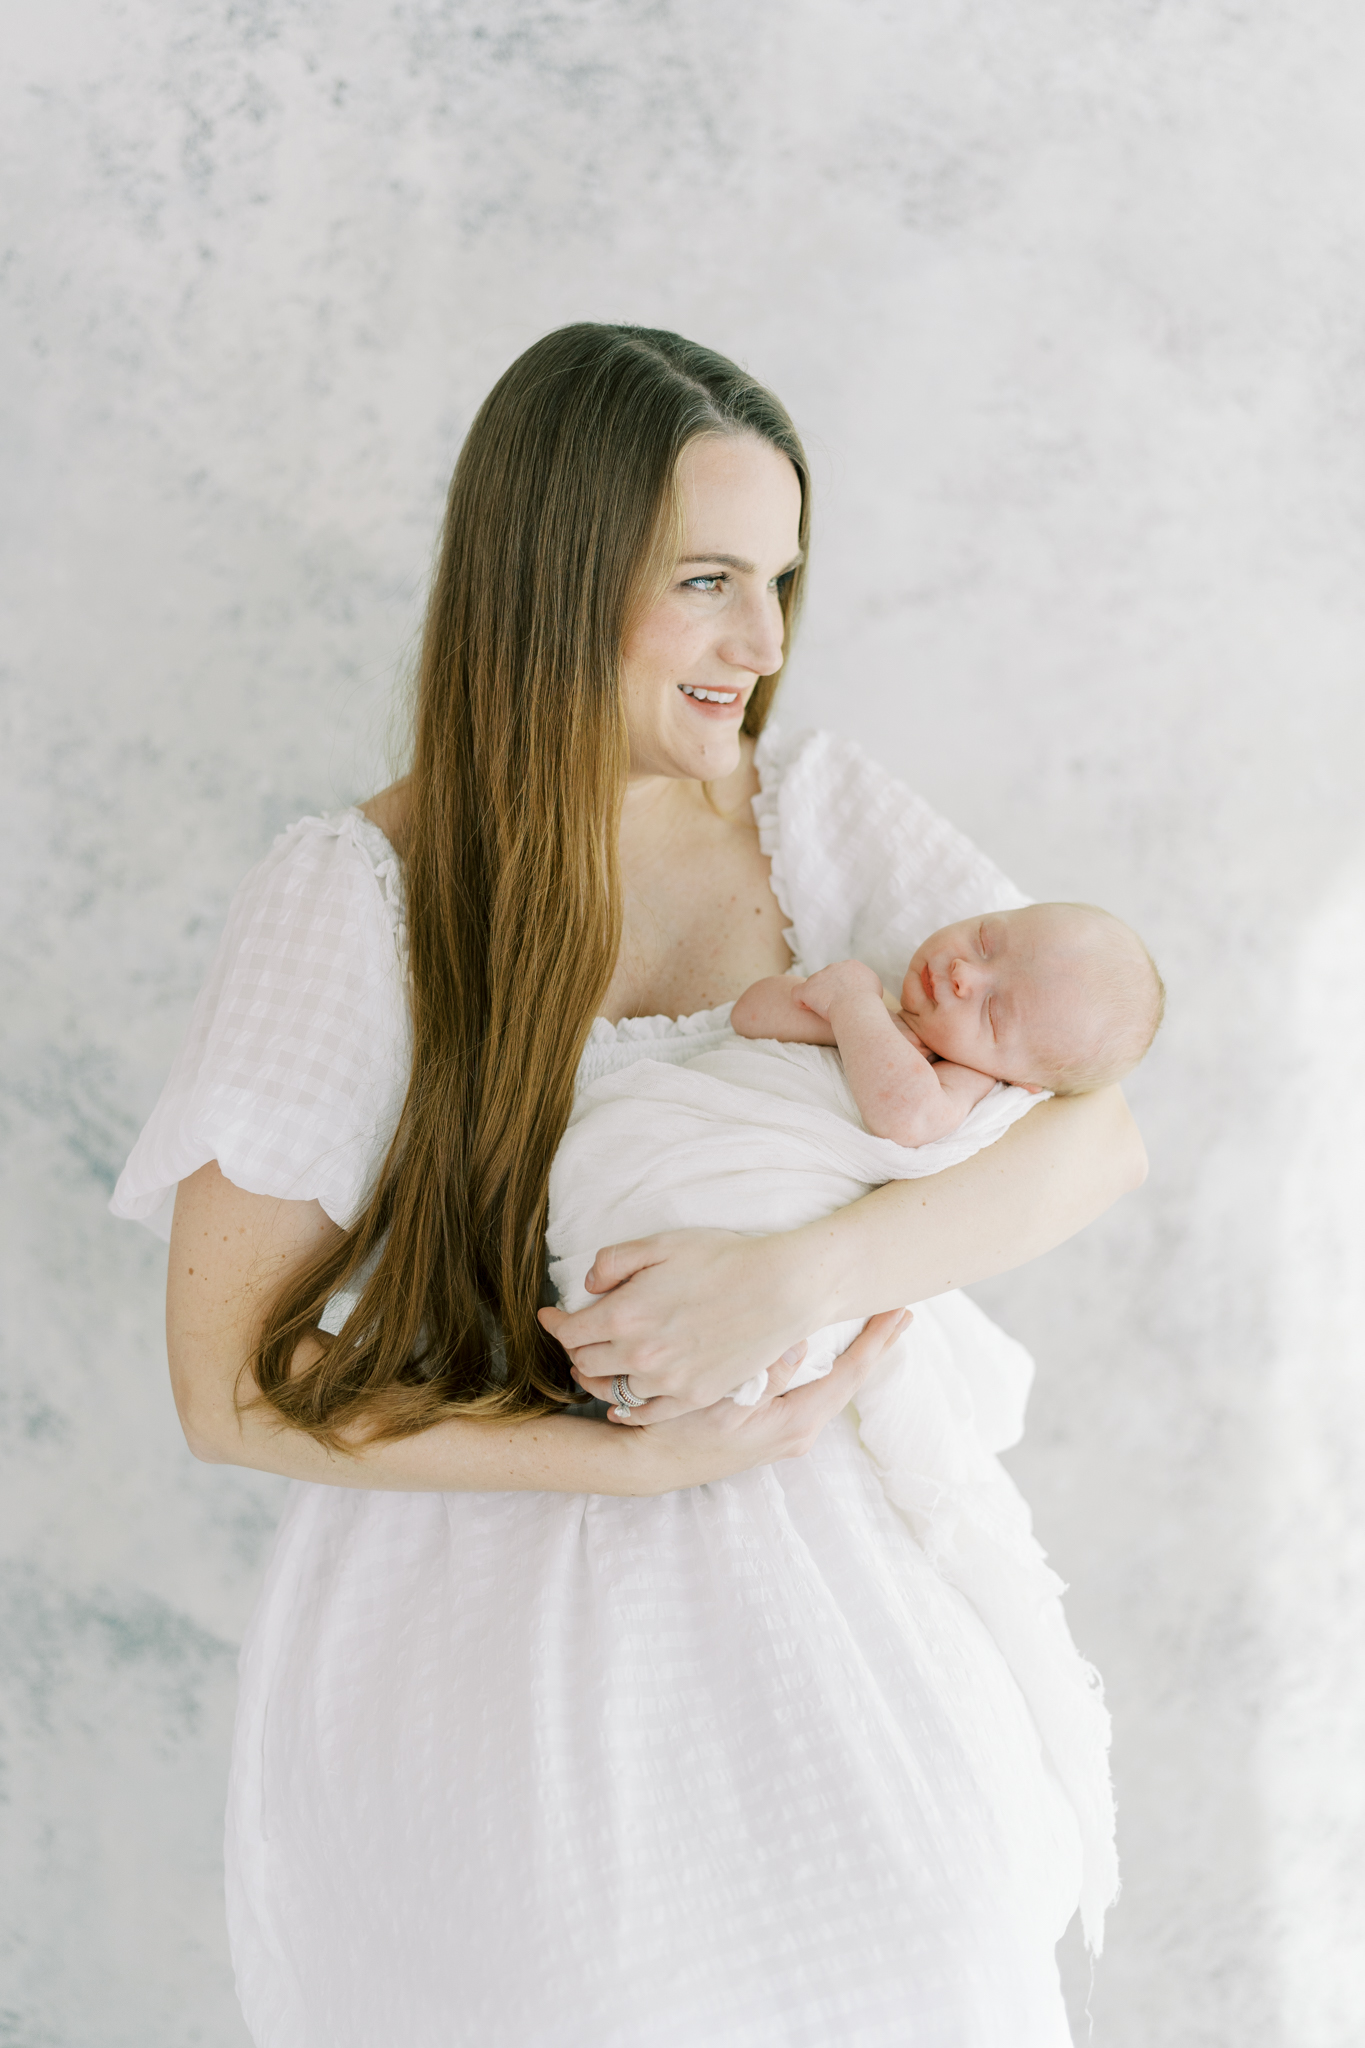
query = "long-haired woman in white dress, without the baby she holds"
xmin=115 ymin=326 xmax=1142 ymax=2048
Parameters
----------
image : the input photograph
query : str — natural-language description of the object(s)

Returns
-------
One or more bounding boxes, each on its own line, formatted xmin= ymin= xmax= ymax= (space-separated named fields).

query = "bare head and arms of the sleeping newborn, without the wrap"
xmin=731 ymin=903 xmax=1164 ymax=1145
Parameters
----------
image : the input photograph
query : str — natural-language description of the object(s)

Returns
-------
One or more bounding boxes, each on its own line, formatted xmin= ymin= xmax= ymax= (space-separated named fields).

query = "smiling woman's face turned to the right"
xmin=622 ymin=434 xmax=800 ymax=782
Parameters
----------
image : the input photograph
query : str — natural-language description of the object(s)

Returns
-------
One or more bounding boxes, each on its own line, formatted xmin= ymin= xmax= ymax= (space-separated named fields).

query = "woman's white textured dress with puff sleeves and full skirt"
xmin=113 ymin=735 xmax=1113 ymax=2048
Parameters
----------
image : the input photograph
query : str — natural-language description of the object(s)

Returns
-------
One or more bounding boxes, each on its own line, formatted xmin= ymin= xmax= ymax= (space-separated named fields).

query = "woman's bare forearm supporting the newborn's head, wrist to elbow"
xmin=784 ymin=1087 xmax=1146 ymax=1327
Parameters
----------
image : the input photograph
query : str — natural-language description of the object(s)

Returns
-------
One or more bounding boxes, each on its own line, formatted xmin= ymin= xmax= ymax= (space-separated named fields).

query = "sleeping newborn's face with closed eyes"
xmin=900 ymin=903 xmax=1089 ymax=1087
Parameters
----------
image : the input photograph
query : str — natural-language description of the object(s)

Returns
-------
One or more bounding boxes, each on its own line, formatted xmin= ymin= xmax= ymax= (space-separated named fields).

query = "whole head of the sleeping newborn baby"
xmin=900 ymin=903 xmax=1166 ymax=1096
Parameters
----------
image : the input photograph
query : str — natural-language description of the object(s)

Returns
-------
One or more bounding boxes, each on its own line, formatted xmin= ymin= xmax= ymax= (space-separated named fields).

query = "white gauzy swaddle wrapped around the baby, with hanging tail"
xmin=546 ymin=1034 xmax=1117 ymax=1950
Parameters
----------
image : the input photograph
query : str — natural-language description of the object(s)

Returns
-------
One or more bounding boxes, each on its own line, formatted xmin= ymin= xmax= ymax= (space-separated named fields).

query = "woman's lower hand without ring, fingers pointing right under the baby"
xmin=630 ymin=1309 xmax=911 ymax=1493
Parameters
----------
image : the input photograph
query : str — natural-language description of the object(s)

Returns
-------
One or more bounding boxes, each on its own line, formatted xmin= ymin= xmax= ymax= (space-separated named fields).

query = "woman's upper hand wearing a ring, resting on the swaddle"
xmin=540 ymin=1229 xmax=834 ymax=1415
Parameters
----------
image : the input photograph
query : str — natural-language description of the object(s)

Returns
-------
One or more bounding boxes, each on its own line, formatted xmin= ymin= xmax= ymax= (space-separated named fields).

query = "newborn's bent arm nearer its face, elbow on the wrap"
xmin=802 ymin=961 xmax=995 ymax=1145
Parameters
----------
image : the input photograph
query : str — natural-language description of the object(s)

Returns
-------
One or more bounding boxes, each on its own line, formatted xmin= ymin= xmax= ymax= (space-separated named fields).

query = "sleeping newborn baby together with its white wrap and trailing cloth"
xmin=546 ymin=903 xmax=1160 ymax=1933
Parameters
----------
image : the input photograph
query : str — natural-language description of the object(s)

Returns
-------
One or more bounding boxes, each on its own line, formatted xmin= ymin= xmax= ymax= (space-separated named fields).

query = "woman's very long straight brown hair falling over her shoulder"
xmin=250 ymin=324 xmax=810 ymax=1444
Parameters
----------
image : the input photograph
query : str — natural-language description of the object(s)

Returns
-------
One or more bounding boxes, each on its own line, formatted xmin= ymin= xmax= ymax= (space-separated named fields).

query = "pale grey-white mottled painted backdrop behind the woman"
xmin=0 ymin=0 xmax=1365 ymax=2048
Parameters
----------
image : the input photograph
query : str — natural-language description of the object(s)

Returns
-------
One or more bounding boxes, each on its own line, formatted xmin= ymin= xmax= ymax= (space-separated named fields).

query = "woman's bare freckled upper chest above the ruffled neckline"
xmin=602 ymin=831 xmax=792 ymax=1024
